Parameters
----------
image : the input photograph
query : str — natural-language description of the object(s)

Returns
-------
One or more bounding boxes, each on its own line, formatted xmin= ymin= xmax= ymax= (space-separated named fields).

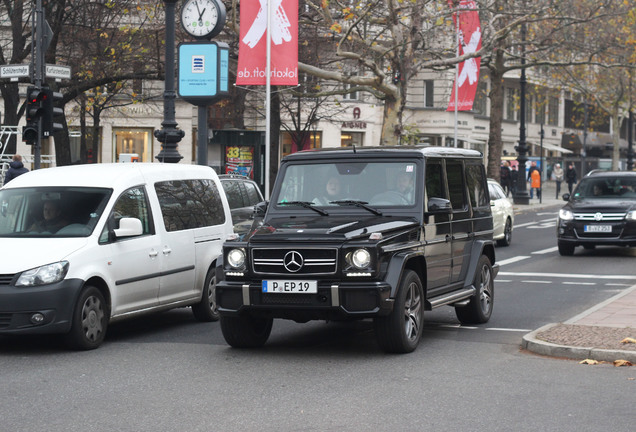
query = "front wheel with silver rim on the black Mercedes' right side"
xmin=374 ymin=270 xmax=424 ymax=354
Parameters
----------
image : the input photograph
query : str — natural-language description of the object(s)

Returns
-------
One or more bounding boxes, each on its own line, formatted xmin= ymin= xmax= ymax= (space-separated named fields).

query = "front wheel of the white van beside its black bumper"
xmin=64 ymin=285 xmax=109 ymax=350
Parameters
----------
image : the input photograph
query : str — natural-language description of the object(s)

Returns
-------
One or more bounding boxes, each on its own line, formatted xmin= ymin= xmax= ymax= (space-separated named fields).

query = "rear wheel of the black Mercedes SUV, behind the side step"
xmin=455 ymin=255 xmax=495 ymax=324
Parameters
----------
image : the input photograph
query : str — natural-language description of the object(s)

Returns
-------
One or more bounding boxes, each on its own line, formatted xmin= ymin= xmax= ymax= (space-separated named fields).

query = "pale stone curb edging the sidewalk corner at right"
xmin=521 ymin=323 xmax=636 ymax=364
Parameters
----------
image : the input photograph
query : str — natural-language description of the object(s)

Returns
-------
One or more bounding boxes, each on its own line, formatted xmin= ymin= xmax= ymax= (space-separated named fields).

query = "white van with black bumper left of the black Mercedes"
xmin=0 ymin=163 xmax=232 ymax=349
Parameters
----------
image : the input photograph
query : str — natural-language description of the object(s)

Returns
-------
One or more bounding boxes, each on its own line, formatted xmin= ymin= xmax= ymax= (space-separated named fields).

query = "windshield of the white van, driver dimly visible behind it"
xmin=0 ymin=187 xmax=112 ymax=238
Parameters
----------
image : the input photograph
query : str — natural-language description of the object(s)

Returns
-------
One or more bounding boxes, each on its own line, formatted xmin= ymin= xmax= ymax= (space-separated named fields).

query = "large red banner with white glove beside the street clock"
xmin=236 ymin=0 xmax=298 ymax=85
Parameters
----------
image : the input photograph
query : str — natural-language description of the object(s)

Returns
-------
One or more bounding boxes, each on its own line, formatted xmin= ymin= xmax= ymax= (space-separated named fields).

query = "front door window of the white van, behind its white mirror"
xmin=99 ymin=186 xmax=155 ymax=243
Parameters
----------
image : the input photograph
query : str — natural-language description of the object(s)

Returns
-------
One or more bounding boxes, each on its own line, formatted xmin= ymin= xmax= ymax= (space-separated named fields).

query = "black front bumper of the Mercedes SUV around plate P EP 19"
xmin=216 ymin=280 xmax=393 ymax=322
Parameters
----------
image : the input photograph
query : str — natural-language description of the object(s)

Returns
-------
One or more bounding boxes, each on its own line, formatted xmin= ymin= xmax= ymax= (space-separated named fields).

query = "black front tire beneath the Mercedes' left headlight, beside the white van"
xmin=221 ymin=315 xmax=274 ymax=348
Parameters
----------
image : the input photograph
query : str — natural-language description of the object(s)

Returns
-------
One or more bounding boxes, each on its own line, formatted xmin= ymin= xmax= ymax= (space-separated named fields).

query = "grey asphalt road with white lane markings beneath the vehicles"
xmin=0 ymin=207 xmax=636 ymax=432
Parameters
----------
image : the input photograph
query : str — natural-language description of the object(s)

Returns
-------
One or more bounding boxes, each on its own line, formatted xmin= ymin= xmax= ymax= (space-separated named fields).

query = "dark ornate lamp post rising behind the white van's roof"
xmin=155 ymin=0 xmax=185 ymax=163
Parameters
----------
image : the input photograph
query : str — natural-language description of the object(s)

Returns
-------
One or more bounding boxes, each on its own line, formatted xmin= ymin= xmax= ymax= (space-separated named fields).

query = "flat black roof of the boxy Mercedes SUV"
xmin=284 ymin=146 xmax=483 ymax=160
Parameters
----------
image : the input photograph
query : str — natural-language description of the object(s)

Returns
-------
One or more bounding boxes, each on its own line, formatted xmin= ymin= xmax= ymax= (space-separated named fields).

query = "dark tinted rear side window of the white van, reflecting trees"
xmin=155 ymin=179 xmax=225 ymax=231
